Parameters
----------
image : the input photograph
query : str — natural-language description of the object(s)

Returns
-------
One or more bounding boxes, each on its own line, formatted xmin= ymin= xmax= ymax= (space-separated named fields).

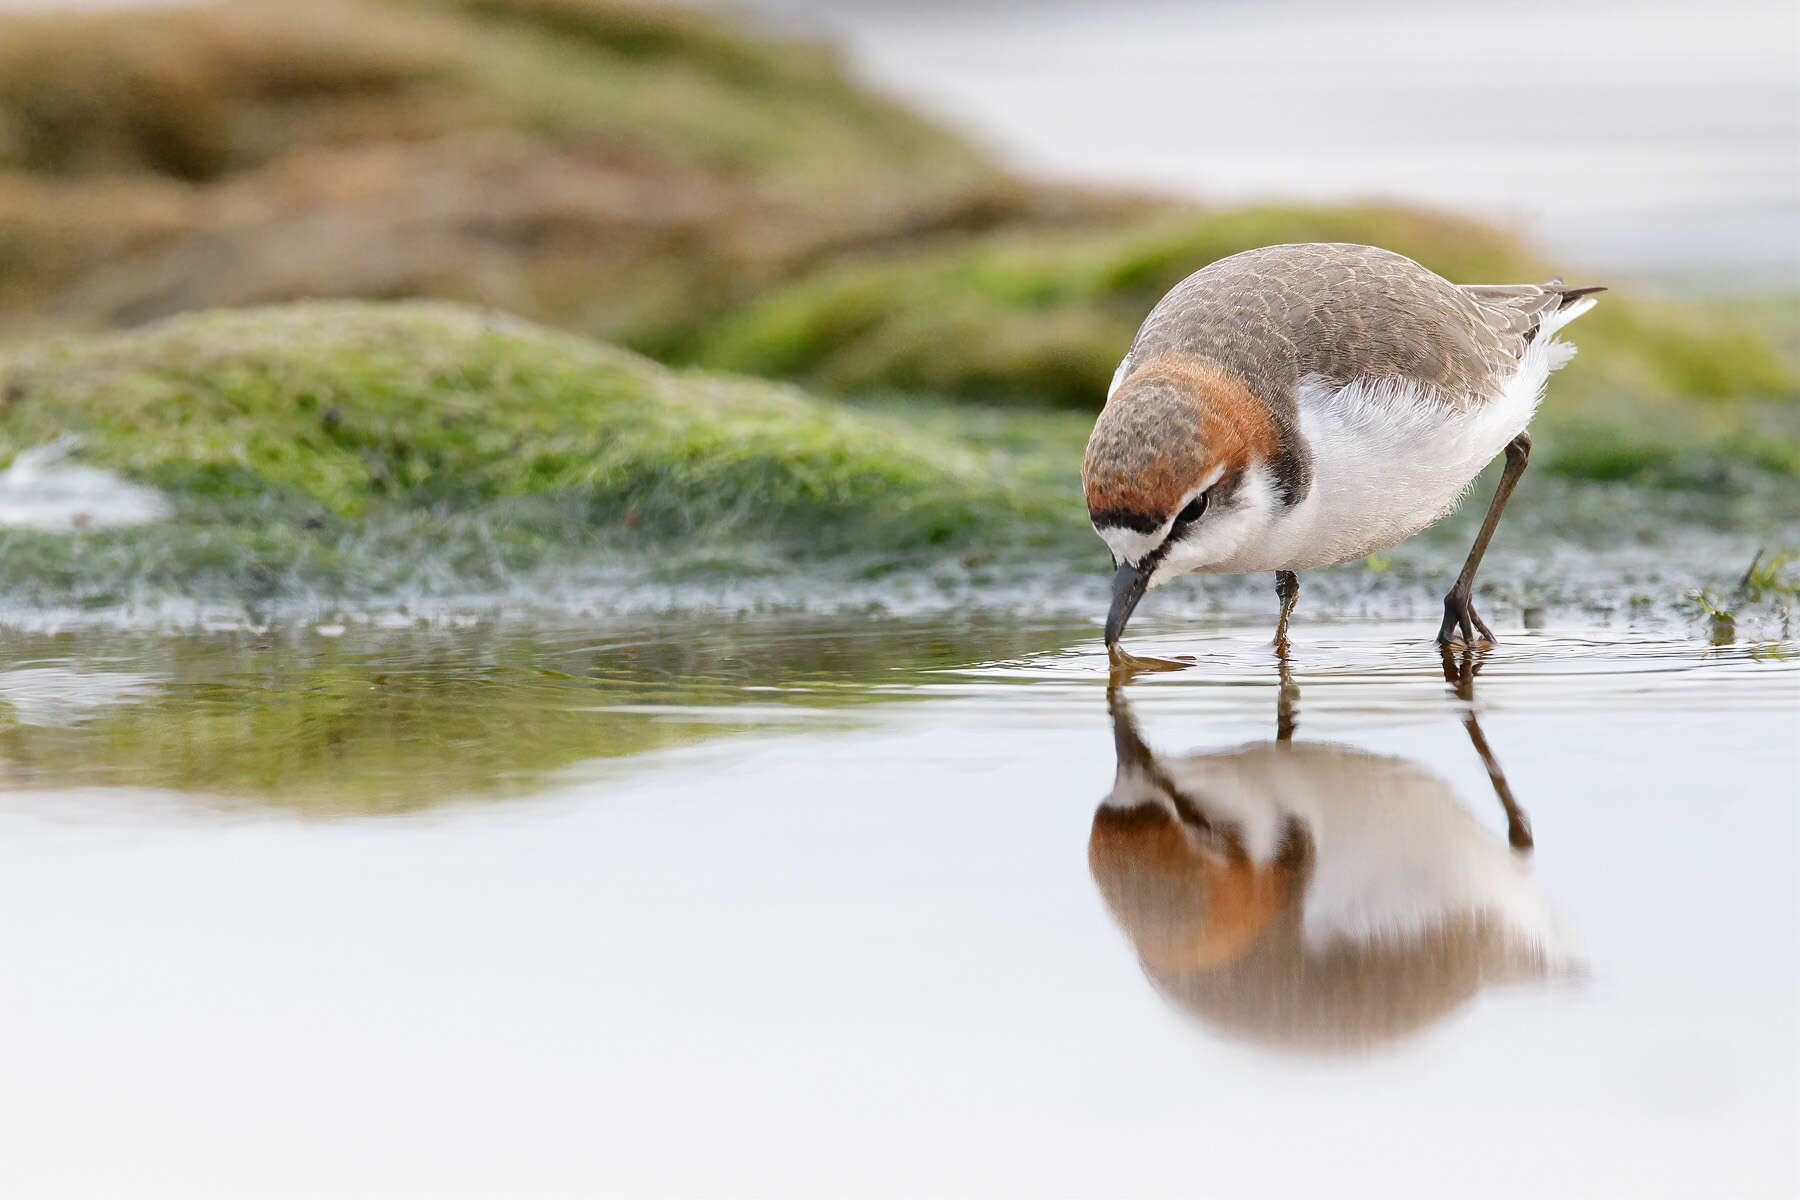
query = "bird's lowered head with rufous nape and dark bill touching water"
xmin=1082 ymin=356 xmax=1282 ymax=646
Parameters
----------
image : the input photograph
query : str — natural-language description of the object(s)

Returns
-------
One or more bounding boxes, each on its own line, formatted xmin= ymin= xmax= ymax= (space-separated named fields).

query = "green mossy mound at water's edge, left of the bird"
xmin=0 ymin=302 xmax=1075 ymax=604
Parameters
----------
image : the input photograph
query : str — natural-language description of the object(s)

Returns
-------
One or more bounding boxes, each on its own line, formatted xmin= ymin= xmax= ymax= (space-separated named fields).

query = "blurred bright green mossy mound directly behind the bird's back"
xmin=662 ymin=207 xmax=1800 ymax=410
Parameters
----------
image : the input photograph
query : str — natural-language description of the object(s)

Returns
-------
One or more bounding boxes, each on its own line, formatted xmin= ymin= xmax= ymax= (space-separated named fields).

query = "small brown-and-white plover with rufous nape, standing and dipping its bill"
xmin=1082 ymin=243 xmax=1606 ymax=653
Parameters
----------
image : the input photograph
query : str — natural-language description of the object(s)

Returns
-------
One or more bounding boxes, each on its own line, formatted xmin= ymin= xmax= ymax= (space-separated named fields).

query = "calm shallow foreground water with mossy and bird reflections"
xmin=0 ymin=613 xmax=1800 ymax=1196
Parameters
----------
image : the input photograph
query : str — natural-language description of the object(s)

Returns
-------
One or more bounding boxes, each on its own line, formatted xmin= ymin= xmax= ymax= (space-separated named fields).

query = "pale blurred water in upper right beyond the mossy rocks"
xmin=758 ymin=0 xmax=1800 ymax=290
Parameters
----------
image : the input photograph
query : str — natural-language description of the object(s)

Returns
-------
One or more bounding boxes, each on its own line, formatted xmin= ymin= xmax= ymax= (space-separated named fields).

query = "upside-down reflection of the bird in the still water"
xmin=1087 ymin=658 xmax=1570 ymax=1051
